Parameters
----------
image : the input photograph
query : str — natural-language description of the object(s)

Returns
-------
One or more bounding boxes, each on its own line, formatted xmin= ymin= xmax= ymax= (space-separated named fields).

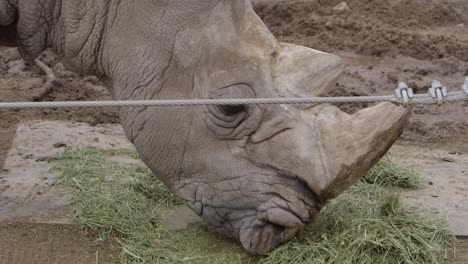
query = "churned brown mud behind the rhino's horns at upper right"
xmin=257 ymin=0 xmax=468 ymax=142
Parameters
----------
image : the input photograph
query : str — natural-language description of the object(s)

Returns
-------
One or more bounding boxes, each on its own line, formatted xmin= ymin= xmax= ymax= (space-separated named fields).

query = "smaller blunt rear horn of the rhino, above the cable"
xmin=273 ymin=43 xmax=344 ymax=97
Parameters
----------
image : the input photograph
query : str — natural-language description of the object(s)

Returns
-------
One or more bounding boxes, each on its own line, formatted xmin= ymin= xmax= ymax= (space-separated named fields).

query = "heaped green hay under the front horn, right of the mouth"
xmin=267 ymin=183 xmax=454 ymax=264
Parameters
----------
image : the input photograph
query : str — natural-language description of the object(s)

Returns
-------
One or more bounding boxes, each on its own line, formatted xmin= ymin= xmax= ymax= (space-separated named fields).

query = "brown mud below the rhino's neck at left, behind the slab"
xmin=0 ymin=47 xmax=119 ymax=168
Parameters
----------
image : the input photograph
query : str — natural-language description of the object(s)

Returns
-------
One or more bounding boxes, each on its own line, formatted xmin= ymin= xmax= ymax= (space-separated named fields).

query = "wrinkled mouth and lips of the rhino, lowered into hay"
xmin=179 ymin=164 xmax=324 ymax=255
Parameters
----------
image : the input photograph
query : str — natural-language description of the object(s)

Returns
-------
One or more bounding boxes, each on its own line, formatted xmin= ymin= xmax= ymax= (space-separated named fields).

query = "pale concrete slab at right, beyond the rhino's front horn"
xmin=391 ymin=145 xmax=468 ymax=237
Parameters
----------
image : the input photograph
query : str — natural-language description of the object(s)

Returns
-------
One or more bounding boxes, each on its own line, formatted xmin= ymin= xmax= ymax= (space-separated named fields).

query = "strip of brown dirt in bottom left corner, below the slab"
xmin=0 ymin=223 xmax=120 ymax=264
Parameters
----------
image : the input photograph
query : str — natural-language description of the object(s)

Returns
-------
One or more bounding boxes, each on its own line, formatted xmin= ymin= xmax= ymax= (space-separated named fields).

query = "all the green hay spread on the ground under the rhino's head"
xmin=53 ymin=148 xmax=454 ymax=264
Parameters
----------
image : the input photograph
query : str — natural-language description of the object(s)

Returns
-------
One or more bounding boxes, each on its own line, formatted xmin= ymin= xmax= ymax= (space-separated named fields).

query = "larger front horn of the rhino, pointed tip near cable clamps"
xmin=302 ymin=103 xmax=411 ymax=200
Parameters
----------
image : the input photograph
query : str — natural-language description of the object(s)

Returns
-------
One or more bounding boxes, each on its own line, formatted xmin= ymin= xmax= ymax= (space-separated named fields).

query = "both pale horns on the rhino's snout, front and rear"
xmin=270 ymin=43 xmax=411 ymax=200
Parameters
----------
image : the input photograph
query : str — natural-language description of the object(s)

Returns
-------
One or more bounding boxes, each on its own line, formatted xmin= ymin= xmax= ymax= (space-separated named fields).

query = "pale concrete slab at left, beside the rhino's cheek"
xmin=0 ymin=121 xmax=132 ymax=223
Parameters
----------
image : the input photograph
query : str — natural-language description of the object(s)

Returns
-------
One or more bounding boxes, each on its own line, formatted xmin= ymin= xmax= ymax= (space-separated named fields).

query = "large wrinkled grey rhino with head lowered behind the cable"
xmin=0 ymin=0 xmax=409 ymax=254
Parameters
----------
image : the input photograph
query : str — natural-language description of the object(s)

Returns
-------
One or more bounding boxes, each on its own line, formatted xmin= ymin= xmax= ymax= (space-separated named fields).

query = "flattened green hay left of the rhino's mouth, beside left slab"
xmin=53 ymin=148 xmax=252 ymax=264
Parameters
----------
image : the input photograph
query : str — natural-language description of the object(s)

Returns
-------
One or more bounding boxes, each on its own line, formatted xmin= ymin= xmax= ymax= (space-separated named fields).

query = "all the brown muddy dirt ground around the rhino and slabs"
xmin=0 ymin=0 xmax=468 ymax=263
